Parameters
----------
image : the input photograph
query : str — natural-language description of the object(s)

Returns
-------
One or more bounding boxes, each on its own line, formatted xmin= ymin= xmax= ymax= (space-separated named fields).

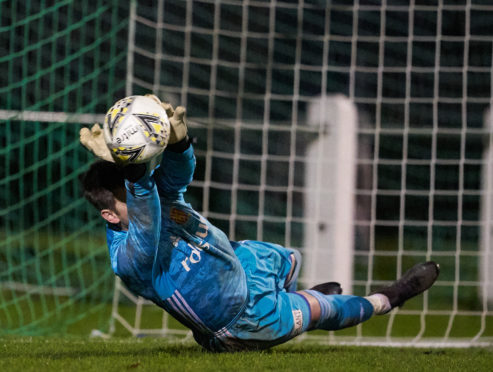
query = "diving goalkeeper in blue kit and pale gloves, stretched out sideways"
xmin=80 ymin=96 xmax=439 ymax=351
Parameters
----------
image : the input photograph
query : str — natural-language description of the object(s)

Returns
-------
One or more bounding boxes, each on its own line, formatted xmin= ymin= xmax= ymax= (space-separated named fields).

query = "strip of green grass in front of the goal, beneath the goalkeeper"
xmin=0 ymin=337 xmax=493 ymax=372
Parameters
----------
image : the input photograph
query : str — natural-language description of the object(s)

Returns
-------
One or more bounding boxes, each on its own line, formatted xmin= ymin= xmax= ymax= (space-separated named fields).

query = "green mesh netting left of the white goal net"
xmin=0 ymin=1 xmax=128 ymax=334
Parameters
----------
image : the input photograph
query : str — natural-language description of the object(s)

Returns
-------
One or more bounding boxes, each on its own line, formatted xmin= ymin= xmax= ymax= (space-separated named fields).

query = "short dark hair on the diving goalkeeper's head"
xmin=79 ymin=160 xmax=125 ymax=210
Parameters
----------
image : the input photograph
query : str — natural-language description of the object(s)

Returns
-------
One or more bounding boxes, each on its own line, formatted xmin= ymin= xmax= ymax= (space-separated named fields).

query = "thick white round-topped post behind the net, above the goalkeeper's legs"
xmin=303 ymin=95 xmax=358 ymax=293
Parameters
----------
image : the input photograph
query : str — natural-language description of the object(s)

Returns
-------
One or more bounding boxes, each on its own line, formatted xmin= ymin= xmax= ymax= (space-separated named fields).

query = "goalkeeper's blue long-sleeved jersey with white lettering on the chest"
xmin=107 ymin=146 xmax=247 ymax=334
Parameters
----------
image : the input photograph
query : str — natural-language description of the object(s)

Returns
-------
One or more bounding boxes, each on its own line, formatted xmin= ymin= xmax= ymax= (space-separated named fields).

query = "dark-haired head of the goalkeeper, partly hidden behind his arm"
xmin=79 ymin=160 xmax=128 ymax=230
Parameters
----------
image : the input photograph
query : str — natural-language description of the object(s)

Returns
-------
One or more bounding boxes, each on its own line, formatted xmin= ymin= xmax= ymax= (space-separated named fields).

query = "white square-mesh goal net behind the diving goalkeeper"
xmin=109 ymin=0 xmax=493 ymax=346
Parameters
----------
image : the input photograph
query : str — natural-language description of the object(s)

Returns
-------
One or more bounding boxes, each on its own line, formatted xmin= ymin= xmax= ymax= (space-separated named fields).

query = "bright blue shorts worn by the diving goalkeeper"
xmin=195 ymin=241 xmax=310 ymax=351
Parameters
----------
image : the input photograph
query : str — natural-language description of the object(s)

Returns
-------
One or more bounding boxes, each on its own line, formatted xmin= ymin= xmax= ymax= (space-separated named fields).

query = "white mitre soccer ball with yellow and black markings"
xmin=103 ymin=96 xmax=170 ymax=164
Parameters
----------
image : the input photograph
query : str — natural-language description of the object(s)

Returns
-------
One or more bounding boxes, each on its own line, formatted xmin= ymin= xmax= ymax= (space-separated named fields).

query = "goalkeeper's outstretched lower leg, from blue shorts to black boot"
xmin=204 ymin=262 xmax=438 ymax=351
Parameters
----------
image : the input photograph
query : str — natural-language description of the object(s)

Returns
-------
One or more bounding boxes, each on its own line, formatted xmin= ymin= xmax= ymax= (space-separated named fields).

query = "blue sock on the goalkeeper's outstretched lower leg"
xmin=304 ymin=289 xmax=373 ymax=331
